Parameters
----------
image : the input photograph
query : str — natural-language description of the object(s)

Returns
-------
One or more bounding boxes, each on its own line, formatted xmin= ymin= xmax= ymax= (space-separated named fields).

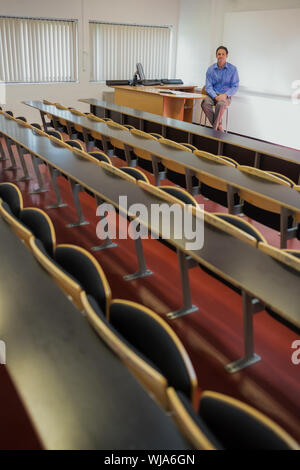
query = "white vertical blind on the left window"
xmin=0 ymin=17 xmax=77 ymax=83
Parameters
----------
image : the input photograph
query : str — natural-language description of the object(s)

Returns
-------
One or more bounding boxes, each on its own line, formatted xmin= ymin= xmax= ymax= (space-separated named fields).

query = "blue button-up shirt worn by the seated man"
xmin=205 ymin=62 xmax=240 ymax=98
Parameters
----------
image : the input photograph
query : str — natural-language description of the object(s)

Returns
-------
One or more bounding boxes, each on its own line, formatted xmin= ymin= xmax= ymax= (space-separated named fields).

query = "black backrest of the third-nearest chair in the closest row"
xmin=54 ymin=246 xmax=106 ymax=312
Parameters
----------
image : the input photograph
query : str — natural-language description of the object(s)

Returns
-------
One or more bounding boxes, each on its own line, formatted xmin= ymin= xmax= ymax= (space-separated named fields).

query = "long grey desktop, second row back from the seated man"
xmin=26 ymin=101 xmax=300 ymax=218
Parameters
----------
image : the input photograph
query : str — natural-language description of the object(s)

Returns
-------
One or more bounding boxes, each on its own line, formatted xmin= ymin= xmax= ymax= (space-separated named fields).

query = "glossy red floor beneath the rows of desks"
xmin=0 ymin=137 xmax=300 ymax=448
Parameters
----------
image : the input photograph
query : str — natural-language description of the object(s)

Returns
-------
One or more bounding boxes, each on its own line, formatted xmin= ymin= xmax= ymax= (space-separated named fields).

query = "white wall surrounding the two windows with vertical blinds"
xmin=0 ymin=0 xmax=179 ymax=122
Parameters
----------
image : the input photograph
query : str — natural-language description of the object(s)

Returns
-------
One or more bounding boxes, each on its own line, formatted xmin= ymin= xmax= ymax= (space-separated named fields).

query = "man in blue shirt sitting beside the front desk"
xmin=201 ymin=46 xmax=239 ymax=131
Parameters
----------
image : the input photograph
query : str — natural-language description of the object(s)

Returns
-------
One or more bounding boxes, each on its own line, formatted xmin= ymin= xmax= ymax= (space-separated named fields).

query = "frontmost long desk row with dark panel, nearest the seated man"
xmin=79 ymin=98 xmax=300 ymax=182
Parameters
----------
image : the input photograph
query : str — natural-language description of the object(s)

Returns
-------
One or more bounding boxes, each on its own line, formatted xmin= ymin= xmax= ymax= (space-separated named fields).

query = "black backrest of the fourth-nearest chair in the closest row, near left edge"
xmin=20 ymin=209 xmax=54 ymax=256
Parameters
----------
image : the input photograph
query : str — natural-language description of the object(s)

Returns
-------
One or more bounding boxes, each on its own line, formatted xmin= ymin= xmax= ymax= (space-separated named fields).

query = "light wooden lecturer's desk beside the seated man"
xmin=113 ymin=85 xmax=205 ymax=122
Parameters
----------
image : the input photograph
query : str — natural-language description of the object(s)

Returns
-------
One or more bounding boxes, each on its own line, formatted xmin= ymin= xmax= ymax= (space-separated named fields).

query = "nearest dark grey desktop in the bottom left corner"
xmin=0 ymin=218 xmax=188 ymax=450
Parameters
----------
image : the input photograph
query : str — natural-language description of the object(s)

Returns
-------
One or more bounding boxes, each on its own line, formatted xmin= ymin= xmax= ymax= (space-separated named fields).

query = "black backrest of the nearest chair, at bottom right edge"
xmin=199 ymin=396 xmax=288 ymax=450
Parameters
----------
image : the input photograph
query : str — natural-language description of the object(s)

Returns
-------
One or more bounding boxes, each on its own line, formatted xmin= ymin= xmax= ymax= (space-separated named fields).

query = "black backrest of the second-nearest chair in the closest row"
xmin=110 ymin=303 xmax=191 ymax=397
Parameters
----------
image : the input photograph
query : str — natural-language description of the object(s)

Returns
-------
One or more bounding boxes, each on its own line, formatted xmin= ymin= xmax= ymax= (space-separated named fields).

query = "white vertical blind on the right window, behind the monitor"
xmin=89 ymin=22 xmax=172 ymax=81
